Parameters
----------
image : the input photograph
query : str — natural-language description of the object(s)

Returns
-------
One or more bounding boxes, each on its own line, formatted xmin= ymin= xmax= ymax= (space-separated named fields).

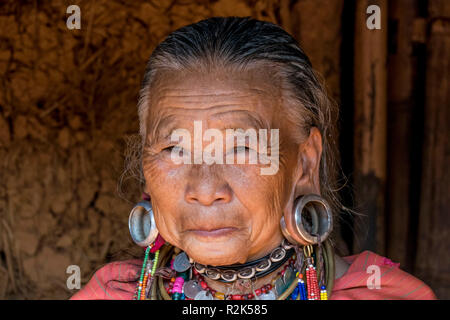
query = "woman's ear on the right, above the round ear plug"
xmin=295 ymin=127 xmax=322 ymax=198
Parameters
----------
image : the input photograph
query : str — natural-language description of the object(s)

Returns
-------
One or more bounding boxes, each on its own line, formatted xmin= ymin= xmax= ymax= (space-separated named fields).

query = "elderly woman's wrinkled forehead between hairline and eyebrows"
xmin=149 ymin=72 xmax=282 ymax=121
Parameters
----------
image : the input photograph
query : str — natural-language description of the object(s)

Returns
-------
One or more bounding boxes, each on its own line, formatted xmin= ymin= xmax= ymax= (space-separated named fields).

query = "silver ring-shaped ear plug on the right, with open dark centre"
xmin=280 ymin=194 xmax=333 ymax=244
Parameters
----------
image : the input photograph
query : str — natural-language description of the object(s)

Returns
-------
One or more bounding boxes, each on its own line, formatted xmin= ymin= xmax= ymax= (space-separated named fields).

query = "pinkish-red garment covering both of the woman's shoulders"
xmin=71 ymin=251 xmax=436 ymax=300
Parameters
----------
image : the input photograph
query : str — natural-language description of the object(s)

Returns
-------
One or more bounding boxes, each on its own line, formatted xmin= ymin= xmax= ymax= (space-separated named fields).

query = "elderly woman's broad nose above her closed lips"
xmin=185 ymin=168 xmax=232 ymax=206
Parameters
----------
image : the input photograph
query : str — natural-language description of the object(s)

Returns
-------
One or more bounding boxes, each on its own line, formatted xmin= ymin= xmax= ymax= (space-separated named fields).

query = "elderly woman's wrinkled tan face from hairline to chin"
xmin=143 ymin=66 xmax=320 ymax=265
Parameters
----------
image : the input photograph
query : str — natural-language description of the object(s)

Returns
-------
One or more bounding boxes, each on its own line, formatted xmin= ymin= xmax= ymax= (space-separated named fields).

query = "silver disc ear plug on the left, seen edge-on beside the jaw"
xmin=128 ymin=201 xmax=158 ymax=247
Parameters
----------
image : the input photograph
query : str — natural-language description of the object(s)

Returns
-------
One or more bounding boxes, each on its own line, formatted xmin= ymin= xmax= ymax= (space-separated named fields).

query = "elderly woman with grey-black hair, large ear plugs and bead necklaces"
xmin=72 ymin=18 xmax=435 ymax=300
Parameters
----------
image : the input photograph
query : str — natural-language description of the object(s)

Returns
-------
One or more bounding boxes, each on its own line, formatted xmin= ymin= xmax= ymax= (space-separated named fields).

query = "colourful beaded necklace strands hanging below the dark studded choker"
xmin=134 ymin=244 xmax=334 ymax=300
